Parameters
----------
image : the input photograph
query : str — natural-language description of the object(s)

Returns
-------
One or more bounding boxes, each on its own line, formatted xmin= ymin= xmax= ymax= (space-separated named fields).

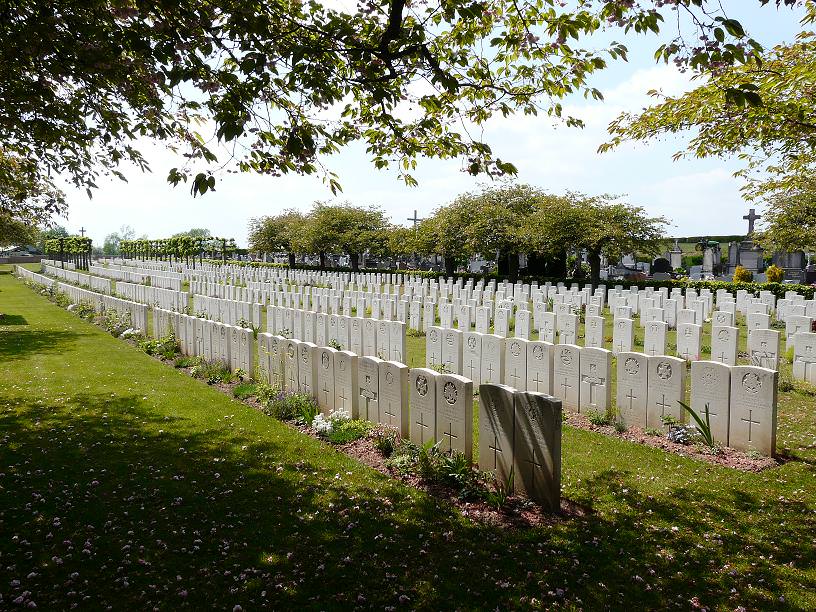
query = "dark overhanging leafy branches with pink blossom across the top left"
xmin=0 ymin=0 xmax=795 ymax=215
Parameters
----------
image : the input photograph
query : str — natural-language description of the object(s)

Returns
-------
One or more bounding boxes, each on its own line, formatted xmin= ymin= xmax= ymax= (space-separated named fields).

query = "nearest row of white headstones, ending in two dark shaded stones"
xmin=154 ymin=309 xmax=562 ymax=510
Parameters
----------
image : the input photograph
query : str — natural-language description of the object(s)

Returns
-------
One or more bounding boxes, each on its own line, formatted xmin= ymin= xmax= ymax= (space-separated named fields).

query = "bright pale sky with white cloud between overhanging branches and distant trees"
xmin=57 ymin=0 xmax=799 ymax=246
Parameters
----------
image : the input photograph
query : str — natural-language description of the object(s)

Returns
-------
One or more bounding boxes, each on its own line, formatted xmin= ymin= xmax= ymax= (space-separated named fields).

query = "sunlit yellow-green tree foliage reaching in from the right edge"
xmin=601 ymin=0 xmax=816 ymax=204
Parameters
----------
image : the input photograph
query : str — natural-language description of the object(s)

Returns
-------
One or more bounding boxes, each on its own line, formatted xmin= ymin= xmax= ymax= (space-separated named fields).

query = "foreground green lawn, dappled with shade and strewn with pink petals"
xmin=0 ymin=274 xmax=816 ymax=610
